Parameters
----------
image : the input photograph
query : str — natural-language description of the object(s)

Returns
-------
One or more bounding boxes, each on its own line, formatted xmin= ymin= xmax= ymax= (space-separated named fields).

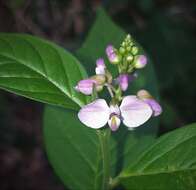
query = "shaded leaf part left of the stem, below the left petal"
xmin=44 ymin=106 xmax=105 ymax=190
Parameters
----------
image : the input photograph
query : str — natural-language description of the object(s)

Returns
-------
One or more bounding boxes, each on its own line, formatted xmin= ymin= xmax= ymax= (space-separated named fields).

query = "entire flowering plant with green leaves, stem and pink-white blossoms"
xmin=0 ymin=9 xmax=196 ymax=190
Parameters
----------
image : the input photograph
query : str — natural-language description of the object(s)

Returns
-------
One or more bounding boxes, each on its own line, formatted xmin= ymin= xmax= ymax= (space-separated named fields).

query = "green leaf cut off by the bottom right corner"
xmin=119 ymin=123 xmax=196 ymax=190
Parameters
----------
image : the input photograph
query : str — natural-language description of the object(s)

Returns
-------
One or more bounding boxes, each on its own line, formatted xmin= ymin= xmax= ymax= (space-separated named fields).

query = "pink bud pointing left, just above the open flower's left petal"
xmin=75 ymin=79 xmax=97 ymax=95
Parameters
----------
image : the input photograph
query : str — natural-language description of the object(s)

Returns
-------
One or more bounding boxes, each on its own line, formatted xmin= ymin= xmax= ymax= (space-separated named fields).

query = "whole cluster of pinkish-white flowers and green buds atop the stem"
xmin=75 ymin=35 xmax=162 ymax=131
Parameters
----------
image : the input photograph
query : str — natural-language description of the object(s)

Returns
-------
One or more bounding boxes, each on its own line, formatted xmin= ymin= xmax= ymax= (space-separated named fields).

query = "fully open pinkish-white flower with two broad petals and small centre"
xmin=78 ymin=96 xmax=153 ymax=131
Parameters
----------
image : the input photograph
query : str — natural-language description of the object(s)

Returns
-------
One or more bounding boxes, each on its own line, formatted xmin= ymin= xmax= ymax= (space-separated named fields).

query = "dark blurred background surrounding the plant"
xmin=0 ymin=0 xmax=196 ymax=190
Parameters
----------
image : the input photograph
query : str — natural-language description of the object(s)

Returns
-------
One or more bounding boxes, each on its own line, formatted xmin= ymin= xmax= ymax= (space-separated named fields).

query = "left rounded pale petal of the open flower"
xmin=78 ymin=99 xmax=110 ymax=129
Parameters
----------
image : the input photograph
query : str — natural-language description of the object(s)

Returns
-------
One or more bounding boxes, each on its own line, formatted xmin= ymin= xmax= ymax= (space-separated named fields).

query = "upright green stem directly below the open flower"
xmin=98 ymin=129 xmax=111 ymax=190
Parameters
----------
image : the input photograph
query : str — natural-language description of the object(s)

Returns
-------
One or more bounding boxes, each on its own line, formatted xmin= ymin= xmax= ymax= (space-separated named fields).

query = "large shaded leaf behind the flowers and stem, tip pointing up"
xmin=44 ymin=9 xmax=161 ymax=190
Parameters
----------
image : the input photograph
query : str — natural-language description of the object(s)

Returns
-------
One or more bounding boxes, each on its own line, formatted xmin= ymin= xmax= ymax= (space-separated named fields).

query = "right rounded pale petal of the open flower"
xmin=120 ymin=96 xmax=152 ymax=127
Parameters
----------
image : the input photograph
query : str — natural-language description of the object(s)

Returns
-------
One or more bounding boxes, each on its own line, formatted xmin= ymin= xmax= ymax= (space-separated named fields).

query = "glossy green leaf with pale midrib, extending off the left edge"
xmin=0 ymin=34 xmax=86 ymax=109
